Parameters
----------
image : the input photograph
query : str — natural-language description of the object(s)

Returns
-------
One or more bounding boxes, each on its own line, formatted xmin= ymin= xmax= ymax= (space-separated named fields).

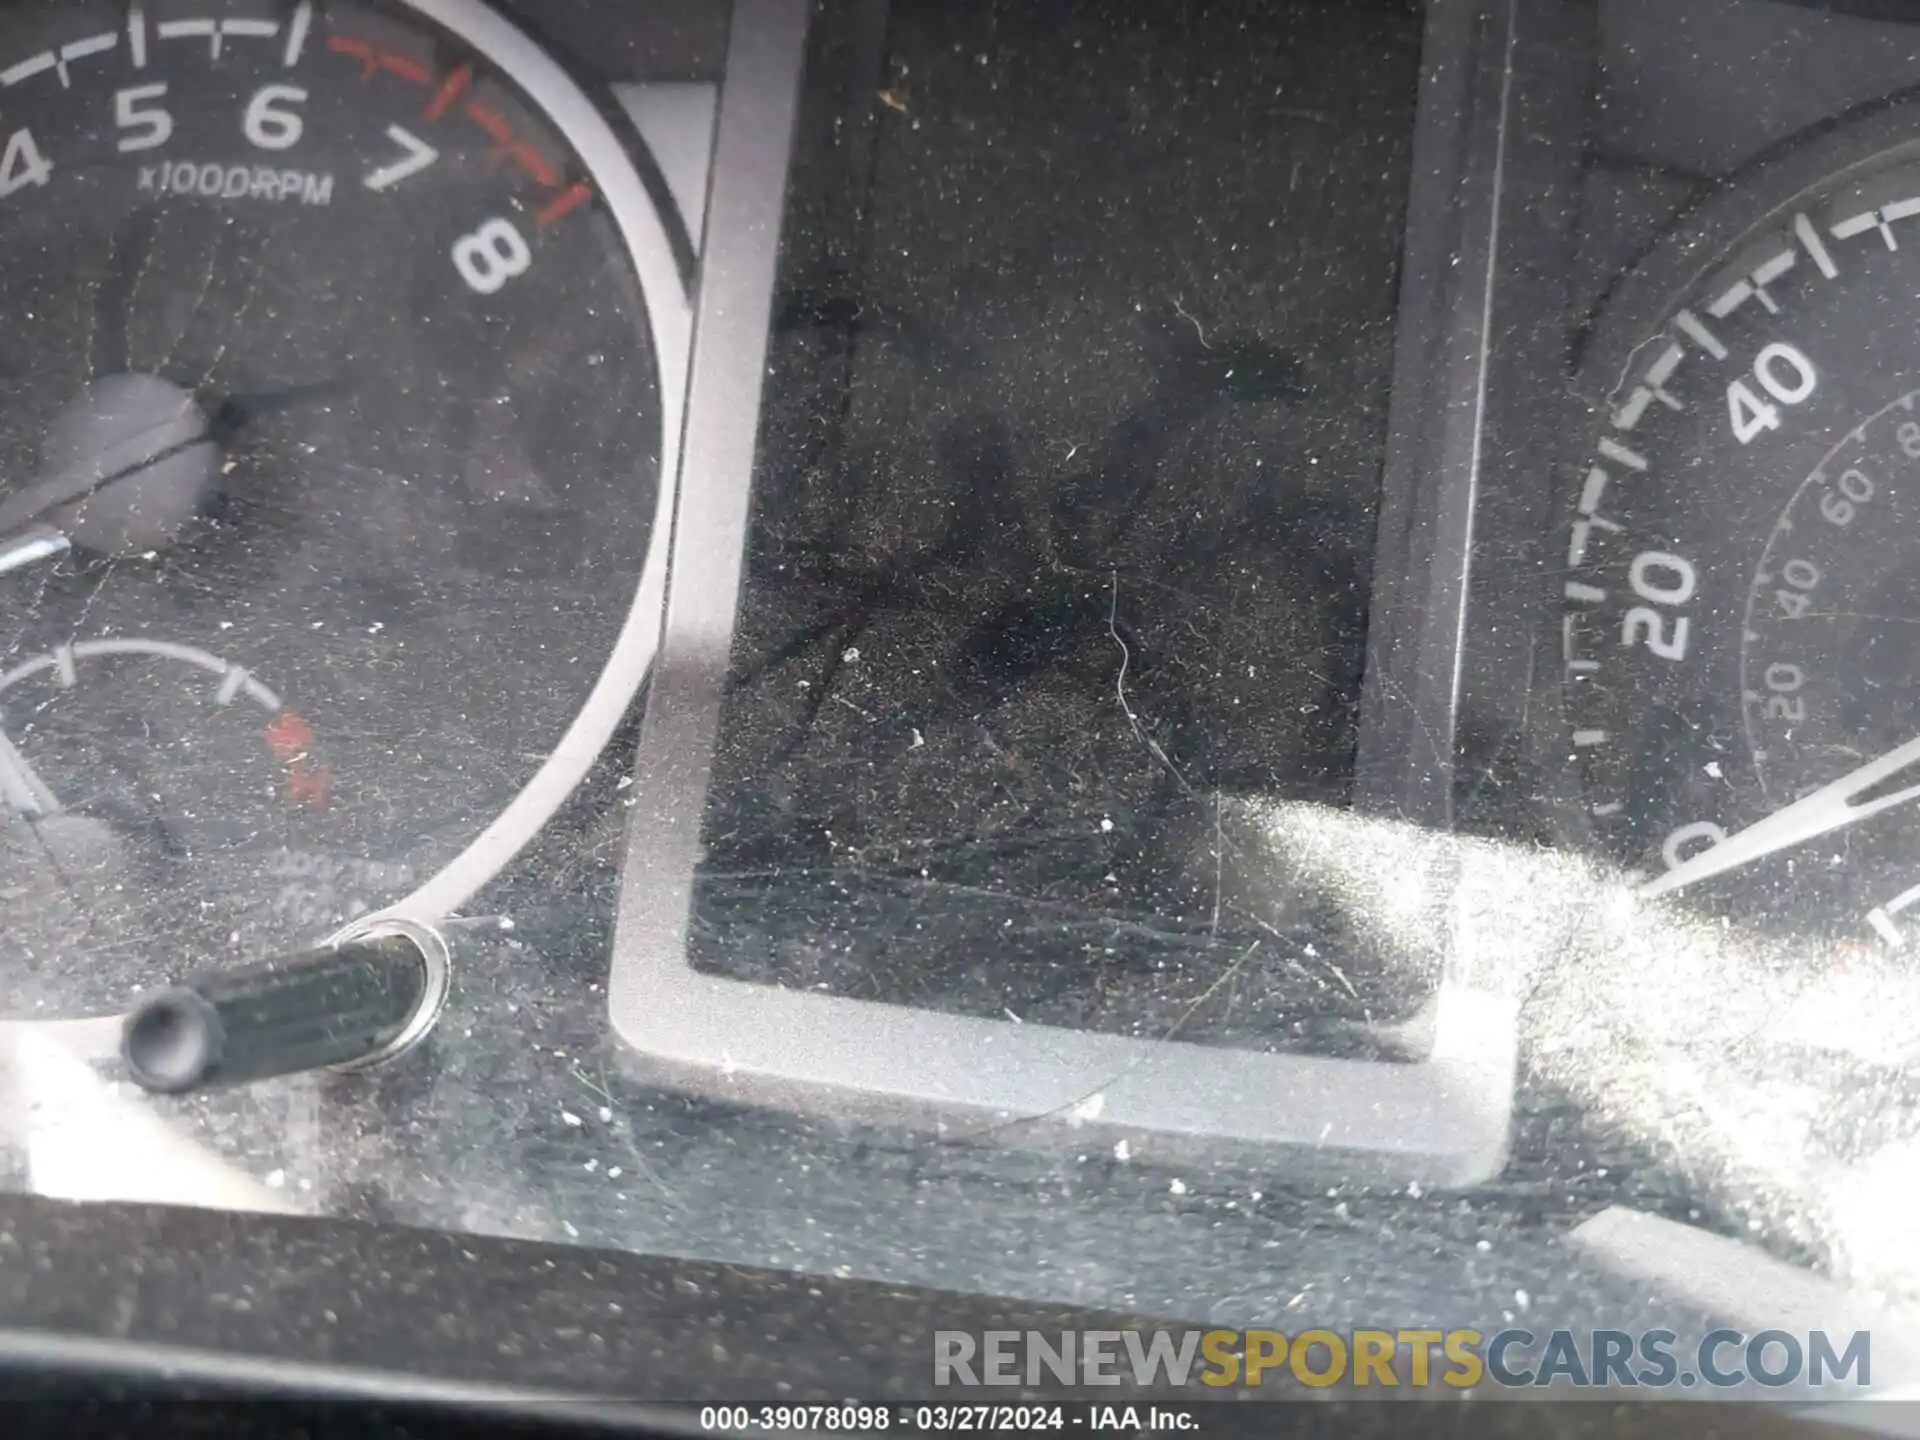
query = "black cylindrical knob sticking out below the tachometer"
xmin=121 ymin=922 xmax=447 ymax=1094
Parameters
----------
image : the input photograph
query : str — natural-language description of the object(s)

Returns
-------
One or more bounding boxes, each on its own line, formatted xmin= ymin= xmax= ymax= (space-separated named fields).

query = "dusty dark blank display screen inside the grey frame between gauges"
xmin=689 ymin=0 xmax=1432 ymax=1048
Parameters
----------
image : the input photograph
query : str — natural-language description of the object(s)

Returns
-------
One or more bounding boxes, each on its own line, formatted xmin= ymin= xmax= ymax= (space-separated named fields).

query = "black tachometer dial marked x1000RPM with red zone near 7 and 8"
xmin=0 ymin=0 xmax=684 ymax=1008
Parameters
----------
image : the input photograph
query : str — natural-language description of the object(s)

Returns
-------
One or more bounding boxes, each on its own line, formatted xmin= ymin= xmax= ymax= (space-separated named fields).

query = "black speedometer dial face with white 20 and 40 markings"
xmin=1555 ymin=108 xmax=1920 ymax=947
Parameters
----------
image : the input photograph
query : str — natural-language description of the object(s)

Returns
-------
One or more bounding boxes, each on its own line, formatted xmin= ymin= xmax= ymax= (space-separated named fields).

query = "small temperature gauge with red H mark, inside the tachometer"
xmin=0 ymin=637 xmax=346 ymax=1002
